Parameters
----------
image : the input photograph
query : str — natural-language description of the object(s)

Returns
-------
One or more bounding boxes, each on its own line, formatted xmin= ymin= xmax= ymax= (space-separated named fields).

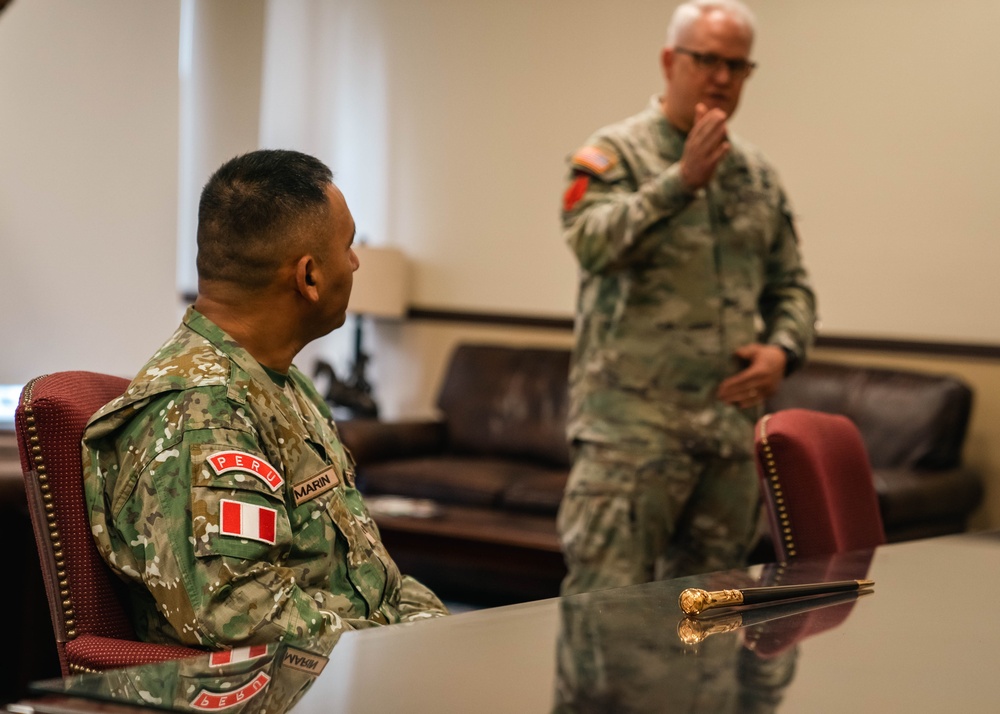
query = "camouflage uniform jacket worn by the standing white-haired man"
xmin=562 ymin=97 xmax=815 ymax=456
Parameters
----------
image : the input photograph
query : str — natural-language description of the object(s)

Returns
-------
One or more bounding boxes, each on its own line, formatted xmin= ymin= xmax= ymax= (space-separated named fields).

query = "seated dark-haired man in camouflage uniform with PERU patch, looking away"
xmin=84 ymin=151 xmax=447 ymax=654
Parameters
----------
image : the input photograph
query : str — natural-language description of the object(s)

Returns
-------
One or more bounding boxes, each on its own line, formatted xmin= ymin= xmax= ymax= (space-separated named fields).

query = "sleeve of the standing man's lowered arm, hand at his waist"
xmin=760 ymin=194 xmax=816 ymax=364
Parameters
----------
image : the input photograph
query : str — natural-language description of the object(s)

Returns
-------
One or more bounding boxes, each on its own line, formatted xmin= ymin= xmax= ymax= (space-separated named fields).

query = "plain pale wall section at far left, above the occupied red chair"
xmin=0 ymin=0 xmax=180 ymax=384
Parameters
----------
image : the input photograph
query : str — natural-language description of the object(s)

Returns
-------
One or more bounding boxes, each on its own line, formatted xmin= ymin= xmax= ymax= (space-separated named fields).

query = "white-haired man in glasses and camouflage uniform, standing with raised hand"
xmin=559 ymin=0 xmax=815 ymax=594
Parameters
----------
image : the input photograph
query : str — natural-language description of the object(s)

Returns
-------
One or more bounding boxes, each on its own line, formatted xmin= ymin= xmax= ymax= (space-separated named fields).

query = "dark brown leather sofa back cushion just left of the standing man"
xmin=438 ymin=344 xmax=570 ymax=467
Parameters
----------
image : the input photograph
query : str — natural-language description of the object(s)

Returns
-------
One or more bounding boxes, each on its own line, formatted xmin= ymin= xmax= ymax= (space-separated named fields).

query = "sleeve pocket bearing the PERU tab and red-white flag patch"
xmin=191 ymin=444 xmax=291 ymax=561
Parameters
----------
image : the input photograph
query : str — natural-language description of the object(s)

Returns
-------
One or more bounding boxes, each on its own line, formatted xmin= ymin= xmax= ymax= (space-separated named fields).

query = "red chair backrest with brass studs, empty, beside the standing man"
xmin=754 ymin=409 xmax=885 ymax=560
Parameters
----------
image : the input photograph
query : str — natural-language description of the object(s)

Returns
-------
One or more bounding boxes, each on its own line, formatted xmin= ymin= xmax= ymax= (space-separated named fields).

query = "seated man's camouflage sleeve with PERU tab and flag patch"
xmin=112 ymin=429 xmax=374 ymax=653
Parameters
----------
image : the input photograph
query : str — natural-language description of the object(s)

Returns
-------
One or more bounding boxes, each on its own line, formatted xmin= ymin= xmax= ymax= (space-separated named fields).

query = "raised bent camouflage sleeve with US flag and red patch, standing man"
xmin=562 ymin=145 xmax=694 ymax=273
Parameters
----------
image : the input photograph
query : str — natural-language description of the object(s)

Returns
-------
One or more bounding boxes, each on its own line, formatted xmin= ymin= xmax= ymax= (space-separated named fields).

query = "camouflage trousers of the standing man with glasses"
xmin=558 ymin=443 xmax=760 ymax=595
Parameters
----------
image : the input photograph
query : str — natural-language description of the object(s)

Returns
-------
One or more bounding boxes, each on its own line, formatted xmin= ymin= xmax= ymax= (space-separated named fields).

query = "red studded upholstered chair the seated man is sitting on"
xmin=15 ymin=372 xmax=203 ymax=676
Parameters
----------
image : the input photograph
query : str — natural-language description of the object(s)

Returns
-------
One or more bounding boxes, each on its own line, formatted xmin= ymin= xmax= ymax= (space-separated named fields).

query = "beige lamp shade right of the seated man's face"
xmin=347 ymin=245 xmax=410 ymax=317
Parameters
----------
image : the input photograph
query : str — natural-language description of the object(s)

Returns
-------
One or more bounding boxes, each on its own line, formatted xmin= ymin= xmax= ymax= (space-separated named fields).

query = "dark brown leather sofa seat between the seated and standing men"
xmin=358 ymin=456 xmax=565 ymax=510
